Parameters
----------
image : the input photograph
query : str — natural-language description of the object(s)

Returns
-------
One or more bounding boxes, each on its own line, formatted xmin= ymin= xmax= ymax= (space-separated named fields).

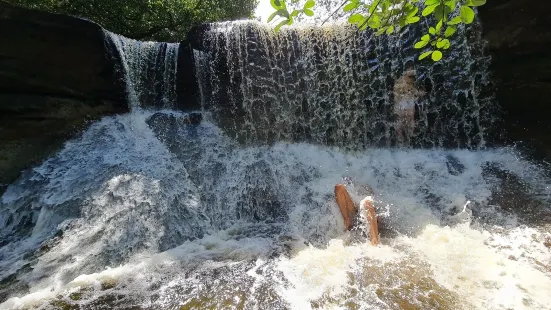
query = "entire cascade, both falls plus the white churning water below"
xmin=0 ymin=17 xmax=551 ymax=310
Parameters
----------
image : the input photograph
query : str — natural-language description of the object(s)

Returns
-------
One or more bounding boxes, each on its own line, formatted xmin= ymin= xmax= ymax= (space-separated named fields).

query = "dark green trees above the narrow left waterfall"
xmin=8 ymin=0 xmax=258 ymax=41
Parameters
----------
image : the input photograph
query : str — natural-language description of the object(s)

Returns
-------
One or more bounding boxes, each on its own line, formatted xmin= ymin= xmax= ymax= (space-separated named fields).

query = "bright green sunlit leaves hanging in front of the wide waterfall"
xmin=268 ymin=0 xmax=486 ymax=61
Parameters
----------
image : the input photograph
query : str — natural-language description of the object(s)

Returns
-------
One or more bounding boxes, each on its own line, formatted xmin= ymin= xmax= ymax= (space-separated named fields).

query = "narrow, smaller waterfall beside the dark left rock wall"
xmin=105 ymin=31 xmax=180 ymax=109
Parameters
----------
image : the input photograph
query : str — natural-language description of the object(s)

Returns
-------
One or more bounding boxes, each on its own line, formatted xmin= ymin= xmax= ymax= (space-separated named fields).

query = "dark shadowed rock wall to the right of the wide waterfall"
xmin=480 ymin=0 xmax=551 ymax=158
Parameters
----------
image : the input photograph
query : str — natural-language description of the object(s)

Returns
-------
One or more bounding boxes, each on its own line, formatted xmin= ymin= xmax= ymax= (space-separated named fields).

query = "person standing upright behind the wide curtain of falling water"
xmin=394 ymin=68 xmax=425 ymax=145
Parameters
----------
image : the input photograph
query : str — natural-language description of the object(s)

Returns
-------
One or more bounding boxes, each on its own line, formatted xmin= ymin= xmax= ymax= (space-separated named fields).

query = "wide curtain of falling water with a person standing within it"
xmin=196 ymin=21 xmax=497 ymax=149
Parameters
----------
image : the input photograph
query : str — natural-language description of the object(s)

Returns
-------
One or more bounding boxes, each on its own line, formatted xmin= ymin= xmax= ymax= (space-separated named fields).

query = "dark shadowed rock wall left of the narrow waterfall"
xmin=0 ymin=1 xmax=128 ymax=193
